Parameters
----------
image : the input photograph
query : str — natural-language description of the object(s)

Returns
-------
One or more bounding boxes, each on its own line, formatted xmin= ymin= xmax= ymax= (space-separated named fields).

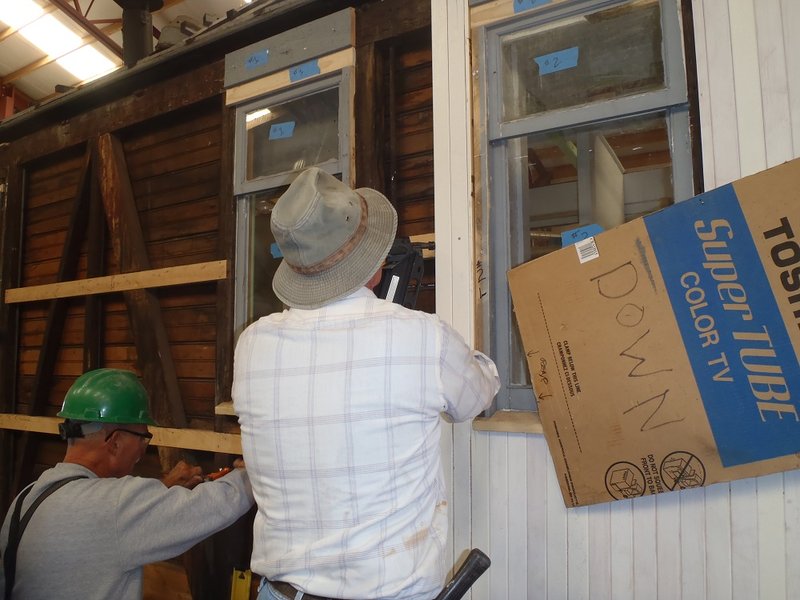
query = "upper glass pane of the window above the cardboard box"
xmin=501 ymin=0 xmax=665 ymax=121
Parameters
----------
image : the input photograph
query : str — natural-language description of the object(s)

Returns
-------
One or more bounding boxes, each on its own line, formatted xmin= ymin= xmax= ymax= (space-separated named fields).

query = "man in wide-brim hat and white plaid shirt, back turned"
xmin=233 ymin=168 xmax=499 ymax=600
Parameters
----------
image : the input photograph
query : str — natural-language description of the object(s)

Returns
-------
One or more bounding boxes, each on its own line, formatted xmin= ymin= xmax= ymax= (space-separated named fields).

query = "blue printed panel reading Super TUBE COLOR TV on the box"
xmin=644 ymin=185 xmax=800 ymax=467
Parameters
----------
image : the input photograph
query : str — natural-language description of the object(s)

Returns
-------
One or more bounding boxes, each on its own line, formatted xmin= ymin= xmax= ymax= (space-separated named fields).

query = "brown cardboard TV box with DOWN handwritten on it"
xmin=508 ymin=160 xmax=800 ymax=506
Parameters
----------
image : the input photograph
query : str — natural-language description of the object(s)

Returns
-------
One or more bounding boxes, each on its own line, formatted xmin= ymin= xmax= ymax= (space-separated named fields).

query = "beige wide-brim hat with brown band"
xmin=270 ymin=167 xmax=397 ymax=309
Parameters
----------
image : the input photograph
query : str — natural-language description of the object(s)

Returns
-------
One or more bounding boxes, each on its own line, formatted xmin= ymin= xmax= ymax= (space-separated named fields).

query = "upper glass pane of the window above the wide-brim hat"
xmin=245 ymin=87 xmax=339 ymax=181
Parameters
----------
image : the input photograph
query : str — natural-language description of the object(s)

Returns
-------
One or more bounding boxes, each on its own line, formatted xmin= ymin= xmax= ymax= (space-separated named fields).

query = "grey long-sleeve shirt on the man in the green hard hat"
xmin=0 ymin=463 xmax=253 ymax=600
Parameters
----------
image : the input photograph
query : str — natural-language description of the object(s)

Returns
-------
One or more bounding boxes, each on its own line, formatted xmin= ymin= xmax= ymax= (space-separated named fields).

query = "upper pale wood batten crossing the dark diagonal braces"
xmin=5 ymin=260 xmax=228 ymax=304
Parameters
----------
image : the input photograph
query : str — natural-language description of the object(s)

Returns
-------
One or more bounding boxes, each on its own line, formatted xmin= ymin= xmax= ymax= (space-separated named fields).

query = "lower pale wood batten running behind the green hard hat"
xmin=0 ymin=413 xmax=242 ymax=455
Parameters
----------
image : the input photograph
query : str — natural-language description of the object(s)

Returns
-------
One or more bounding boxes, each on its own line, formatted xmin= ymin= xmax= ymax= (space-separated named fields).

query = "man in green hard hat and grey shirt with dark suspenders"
xmin=0 ymin=369 xmax=253 ymax=600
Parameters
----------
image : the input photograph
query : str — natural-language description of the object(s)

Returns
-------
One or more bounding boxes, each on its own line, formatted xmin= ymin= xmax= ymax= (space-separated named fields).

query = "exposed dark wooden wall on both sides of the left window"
xmin=0 ymin=0 xmax=435 ymax=488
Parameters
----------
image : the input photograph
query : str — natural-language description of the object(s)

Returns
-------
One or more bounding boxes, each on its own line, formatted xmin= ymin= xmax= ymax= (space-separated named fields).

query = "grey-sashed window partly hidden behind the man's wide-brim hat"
xmin=234 ymin=69 xmax=352 ymax=331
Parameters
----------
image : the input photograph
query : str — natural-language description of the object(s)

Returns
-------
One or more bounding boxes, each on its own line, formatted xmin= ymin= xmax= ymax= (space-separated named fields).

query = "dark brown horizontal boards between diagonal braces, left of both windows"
xmin=17 ymin=101 xmax=222 ymax=429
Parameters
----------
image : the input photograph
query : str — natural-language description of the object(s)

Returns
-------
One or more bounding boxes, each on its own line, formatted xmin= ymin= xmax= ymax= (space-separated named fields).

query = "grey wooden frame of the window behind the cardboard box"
xmin=479 ymin=0 xmax=699 ymax=416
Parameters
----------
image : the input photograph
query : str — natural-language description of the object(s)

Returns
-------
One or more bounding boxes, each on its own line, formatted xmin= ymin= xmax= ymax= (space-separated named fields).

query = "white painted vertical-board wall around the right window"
xmin=431 ymin=0 xmax=800 ymax=600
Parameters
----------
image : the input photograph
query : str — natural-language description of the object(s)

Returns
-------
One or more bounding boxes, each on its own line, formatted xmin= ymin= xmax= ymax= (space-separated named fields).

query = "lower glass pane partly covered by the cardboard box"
xmin=507 ymin=113 xmax=675 ymax=384
